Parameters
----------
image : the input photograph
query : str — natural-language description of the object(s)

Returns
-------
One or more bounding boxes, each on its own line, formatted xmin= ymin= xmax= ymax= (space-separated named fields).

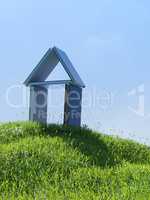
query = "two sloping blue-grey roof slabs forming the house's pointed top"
xmin=24 ymin=47 xmax=85 ymax=87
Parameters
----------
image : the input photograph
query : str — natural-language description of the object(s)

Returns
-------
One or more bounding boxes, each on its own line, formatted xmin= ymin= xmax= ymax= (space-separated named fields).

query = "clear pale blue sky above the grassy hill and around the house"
xmin=0 ymin=0 xmax=150 ymax=144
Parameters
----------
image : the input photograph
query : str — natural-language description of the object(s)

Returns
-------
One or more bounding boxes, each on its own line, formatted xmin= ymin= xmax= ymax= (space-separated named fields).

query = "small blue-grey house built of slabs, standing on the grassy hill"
xmin=24 ymin=47 xmax=85 ymax=126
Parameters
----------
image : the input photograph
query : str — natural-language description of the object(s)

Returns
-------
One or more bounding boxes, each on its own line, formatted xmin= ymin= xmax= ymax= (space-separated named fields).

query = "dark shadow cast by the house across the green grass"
xmin=47 ymin=125 xmax=120 ymax=167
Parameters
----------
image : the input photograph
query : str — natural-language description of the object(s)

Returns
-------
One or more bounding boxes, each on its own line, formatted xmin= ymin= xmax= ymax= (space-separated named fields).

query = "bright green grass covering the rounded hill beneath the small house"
xmin=0 ymin=122 xmax=150 ymax=200
